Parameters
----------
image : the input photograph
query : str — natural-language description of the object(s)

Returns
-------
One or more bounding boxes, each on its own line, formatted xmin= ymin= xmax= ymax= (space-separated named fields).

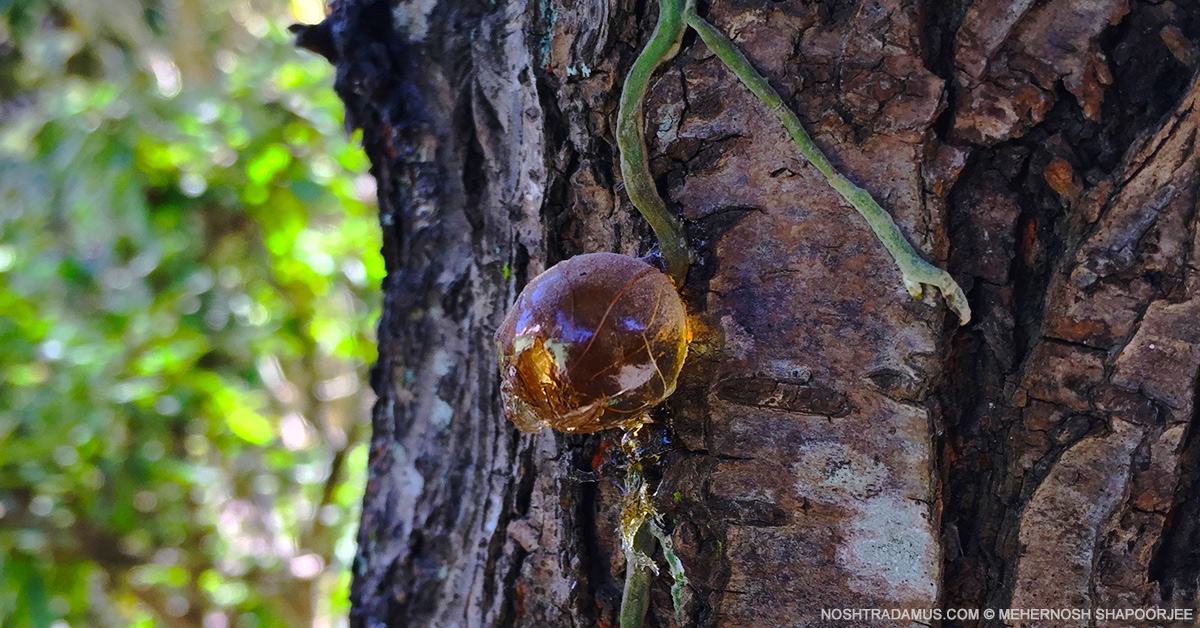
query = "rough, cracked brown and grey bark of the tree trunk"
xmin=302 ymin=0 xmax=1200 ymax=628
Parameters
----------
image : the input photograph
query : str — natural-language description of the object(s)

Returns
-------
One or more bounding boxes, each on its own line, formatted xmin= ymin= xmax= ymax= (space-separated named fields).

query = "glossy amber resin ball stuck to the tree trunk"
xmin=496 ymin=253 xmax=690 ymax=432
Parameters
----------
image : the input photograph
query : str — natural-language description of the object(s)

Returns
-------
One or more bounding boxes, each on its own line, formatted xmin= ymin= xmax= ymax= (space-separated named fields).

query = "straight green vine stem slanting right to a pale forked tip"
xmin=683 ymin=0 xmax=971 ymax=324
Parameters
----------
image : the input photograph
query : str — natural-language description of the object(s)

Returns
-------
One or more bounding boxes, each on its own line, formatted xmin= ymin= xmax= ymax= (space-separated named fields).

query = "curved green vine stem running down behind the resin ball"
xmin=617 ymin=0 xmax=691 ymax=286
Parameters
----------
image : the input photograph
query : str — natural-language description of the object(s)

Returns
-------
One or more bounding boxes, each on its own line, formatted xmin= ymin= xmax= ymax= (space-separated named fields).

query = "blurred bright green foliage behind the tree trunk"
xmin=0 ymin=0 xmax=383 ymax=628
